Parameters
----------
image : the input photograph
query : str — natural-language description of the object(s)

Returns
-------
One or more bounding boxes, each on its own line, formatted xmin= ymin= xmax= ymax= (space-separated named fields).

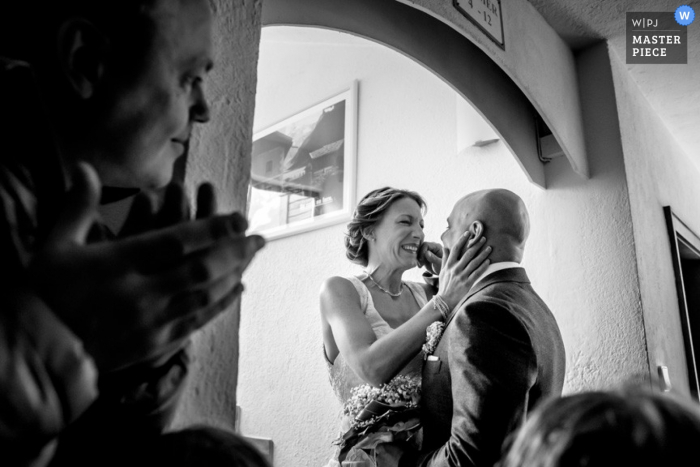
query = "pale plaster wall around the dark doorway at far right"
xmin=610 ymin=44 xmax=700 ymax=392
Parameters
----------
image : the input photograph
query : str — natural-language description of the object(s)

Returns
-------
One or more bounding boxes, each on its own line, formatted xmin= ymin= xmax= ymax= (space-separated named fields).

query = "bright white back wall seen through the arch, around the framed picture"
xmin=237 ymin=26 xmax=547 ymax=466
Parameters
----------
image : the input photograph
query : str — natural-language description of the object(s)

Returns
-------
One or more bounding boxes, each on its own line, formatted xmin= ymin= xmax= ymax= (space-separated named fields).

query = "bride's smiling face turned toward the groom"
xmin=369 ymin=198 xmax=425 ymax=269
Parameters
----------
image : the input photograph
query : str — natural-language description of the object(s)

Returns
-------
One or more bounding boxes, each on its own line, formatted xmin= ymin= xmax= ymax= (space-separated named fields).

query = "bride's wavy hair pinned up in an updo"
xmin=345 ymin=186 xmax=426 ymax=266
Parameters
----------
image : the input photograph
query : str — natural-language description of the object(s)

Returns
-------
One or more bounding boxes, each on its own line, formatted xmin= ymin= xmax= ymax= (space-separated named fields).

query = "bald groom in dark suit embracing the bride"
xmin=401 ymin=189 xmax=565 ymax=467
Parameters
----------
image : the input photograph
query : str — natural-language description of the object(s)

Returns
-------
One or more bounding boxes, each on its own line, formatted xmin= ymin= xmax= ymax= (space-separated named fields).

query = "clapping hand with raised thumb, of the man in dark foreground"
xmin=30 ymin=164 xmax=265 ymax=370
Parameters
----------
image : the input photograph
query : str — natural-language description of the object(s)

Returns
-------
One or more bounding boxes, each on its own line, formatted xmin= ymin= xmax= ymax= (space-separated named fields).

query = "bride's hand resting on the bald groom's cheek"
xmin=439 ymin=232 xmax=491 ymax=309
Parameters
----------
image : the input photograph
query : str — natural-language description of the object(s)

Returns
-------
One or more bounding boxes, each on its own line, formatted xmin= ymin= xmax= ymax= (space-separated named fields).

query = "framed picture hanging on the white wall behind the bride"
xmin=248 ymin=82 xmax=357 ymax=240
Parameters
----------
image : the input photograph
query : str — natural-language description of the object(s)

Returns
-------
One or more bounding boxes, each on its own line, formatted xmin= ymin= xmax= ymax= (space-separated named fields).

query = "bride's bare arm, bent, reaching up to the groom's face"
xmin=320 ymin=234 xmax=491 ymax=386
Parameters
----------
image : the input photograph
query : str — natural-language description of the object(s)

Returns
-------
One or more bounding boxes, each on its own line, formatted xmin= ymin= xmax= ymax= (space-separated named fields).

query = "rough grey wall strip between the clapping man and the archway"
xmin=174 ymin=0 xmax=262 ymax=428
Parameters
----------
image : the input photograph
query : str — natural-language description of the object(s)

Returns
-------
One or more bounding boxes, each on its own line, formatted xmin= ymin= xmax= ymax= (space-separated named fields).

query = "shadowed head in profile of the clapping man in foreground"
xmin=21 ymin=0 xmax=212 ymax=188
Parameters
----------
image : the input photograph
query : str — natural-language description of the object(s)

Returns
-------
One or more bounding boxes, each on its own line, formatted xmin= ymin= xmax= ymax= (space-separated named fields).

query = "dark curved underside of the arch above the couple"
xmin=262 ymin=0 xmax=549 ymax=188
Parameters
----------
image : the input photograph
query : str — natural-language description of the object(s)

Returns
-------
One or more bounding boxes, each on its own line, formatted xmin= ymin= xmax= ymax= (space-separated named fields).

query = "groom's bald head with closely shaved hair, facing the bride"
xmin=442 ymin=189 xmax=530 ymax=263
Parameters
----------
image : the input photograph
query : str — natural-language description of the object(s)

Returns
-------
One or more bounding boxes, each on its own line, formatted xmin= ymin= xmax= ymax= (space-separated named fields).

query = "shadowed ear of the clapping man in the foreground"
xmin=57 ymin=18 xmax=108 ymax=99
